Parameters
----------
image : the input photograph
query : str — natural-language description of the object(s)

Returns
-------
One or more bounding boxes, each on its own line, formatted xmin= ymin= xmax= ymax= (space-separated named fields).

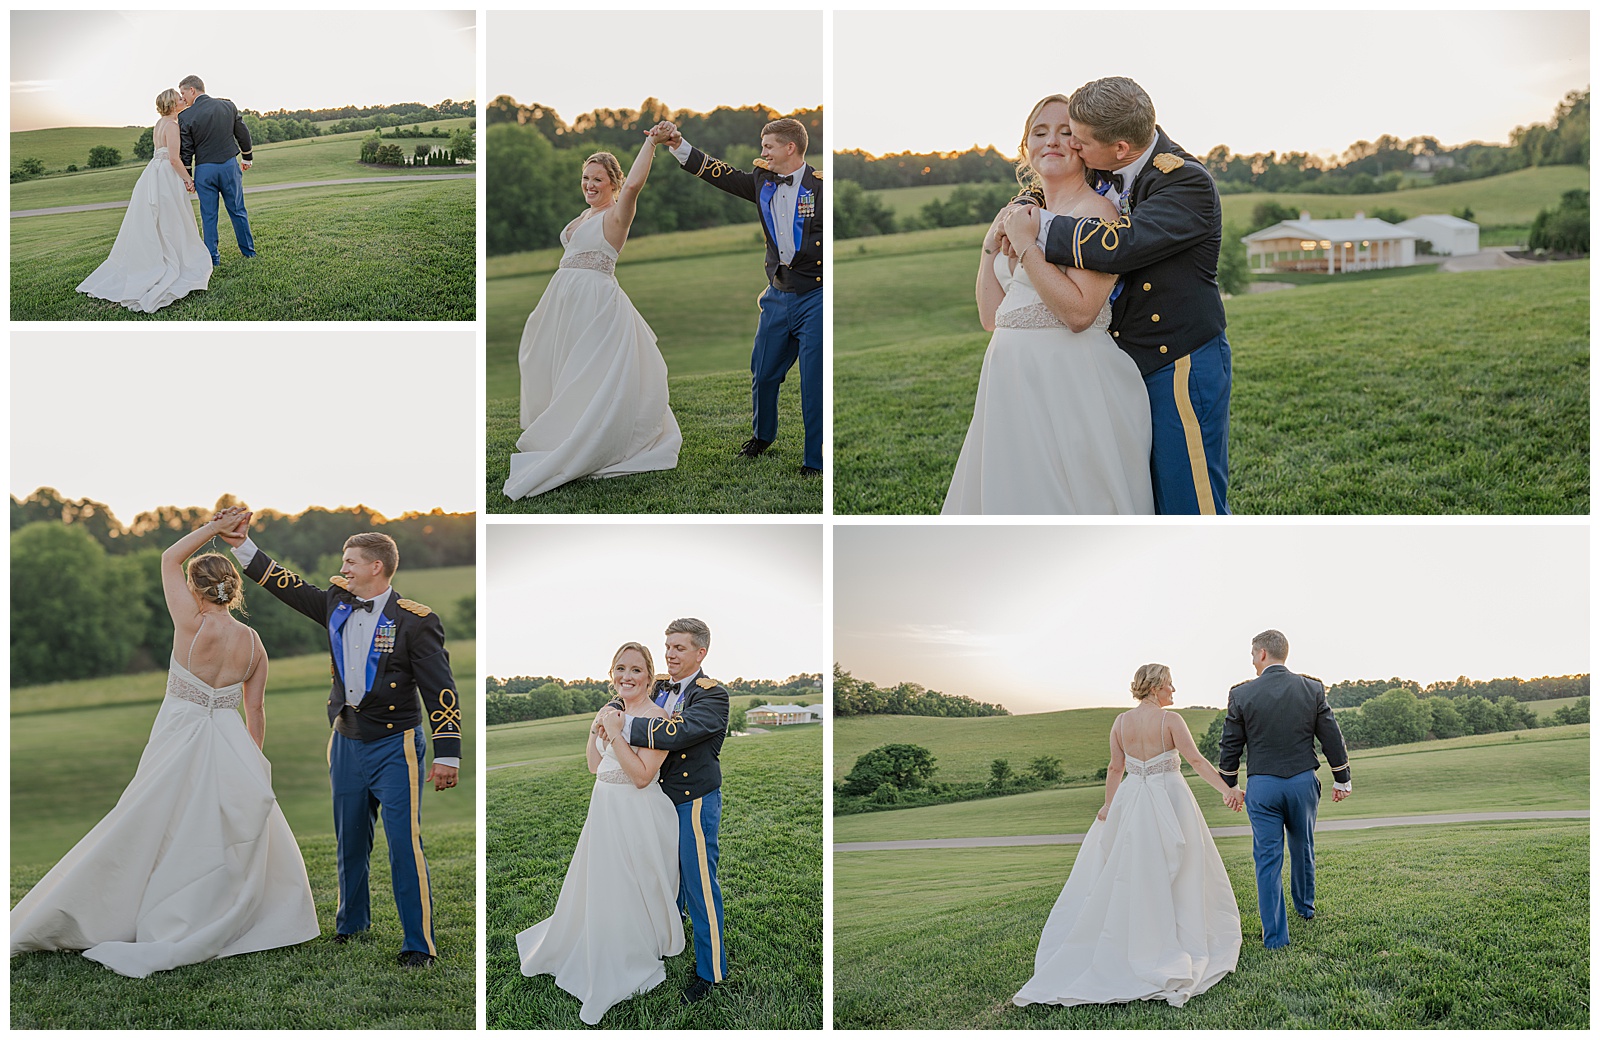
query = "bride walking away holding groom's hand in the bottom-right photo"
xmin=1011 ymin=664 xmax=1243 ymax=1008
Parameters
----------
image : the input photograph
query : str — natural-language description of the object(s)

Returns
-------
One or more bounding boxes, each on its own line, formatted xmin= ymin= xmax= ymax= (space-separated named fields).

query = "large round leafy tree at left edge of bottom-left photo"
xmin=11 ymin=523 xmax=149 ymax=685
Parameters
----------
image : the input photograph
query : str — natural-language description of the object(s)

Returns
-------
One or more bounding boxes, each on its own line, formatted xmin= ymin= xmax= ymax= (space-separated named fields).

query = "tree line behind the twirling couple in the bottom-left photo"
xmin=11 ymin=488 xmax=477 ymax=685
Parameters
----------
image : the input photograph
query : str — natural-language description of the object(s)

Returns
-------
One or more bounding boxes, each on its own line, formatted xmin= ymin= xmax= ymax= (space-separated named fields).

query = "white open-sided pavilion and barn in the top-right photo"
xmin=1243 ymin=211 xmax=1477 ymax=275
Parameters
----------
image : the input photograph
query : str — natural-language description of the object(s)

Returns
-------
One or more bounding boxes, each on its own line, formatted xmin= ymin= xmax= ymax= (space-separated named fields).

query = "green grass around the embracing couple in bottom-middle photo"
xmin=485 ymin=715 xmax=822 ymax=1030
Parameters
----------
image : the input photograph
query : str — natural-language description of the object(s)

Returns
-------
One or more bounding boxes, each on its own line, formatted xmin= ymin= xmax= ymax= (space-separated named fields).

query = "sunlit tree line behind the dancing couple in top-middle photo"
xmin=485 ymin=94 xmax=822 ymax=256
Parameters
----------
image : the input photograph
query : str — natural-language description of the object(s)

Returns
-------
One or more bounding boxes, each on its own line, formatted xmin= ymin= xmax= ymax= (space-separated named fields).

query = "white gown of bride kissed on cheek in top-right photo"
xmin=941 ymin=253 xmax=1155 ymax=514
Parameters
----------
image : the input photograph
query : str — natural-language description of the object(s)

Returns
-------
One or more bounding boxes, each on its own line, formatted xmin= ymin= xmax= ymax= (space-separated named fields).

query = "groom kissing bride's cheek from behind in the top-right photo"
xmin=1011 ymin=75 xmax=1234 ymax=515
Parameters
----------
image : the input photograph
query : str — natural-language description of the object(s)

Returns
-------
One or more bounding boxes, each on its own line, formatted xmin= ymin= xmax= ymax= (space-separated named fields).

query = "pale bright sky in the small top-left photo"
xmin=11 ymin=6 xmax=477 ymax=130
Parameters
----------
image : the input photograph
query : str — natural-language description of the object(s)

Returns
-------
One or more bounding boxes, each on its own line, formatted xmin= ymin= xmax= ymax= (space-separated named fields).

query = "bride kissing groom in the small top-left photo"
xmin=78 ymin=90 xmax=211 ymax=314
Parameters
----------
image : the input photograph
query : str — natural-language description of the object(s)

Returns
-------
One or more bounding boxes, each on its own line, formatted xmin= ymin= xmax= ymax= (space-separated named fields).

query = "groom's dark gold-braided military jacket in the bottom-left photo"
xmin=245 ymin=549 xmax=461 ymax=758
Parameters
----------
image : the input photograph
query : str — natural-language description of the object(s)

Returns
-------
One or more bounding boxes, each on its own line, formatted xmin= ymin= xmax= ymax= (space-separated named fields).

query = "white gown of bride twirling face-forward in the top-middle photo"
xmin=506 ymin=218 xmax=683 ymax=499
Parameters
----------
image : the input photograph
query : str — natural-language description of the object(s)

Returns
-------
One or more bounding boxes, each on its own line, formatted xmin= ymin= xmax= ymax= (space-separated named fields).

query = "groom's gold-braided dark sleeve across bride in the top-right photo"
xmin=1043 ymin=163 xmax=1222 ymax=275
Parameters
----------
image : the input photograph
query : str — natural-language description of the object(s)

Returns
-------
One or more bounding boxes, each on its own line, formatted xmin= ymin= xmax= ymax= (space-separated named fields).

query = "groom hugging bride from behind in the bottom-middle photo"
xmin=622 ymin=618 xmax=728 ymax=1003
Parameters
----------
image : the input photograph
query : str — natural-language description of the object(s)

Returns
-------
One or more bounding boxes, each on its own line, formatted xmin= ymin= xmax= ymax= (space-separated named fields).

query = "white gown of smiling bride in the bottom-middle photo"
xmin=517 ymin=738 xmax=683 ymax=1026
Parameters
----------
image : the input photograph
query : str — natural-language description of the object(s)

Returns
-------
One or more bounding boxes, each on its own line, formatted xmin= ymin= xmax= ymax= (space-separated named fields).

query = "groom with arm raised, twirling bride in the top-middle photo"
xmin=654 ymin=118 xmax=822 ymax=477
